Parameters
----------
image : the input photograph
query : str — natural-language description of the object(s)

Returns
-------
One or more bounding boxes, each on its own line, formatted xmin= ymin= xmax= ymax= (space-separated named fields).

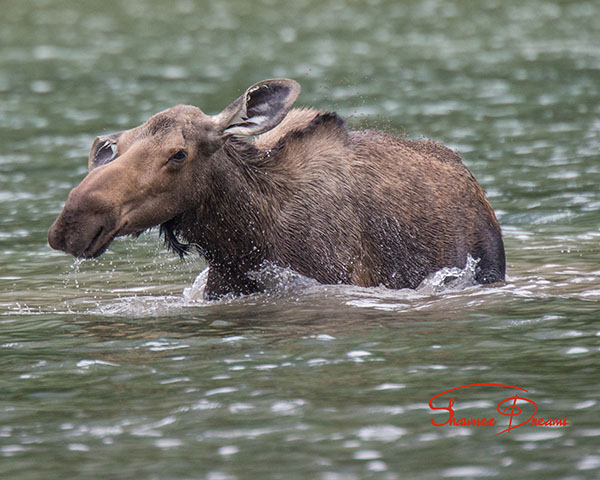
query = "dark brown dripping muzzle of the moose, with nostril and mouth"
xmin=48 ymin=185 xmax=118 ymax=258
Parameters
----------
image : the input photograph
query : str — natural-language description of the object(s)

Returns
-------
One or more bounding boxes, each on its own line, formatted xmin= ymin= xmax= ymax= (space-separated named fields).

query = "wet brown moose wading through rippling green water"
xmin=48 ymin=79 xmax=505 ymax=299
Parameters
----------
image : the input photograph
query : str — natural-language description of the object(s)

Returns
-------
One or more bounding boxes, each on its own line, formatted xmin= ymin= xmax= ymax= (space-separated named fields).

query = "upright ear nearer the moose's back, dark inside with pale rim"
xmin=213 ymin=78 xmax=300 ymax=136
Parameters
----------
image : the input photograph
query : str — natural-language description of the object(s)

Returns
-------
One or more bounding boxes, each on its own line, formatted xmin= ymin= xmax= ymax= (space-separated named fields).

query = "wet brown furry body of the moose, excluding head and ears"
xmin=172 ymin=109 xmax=504 ymax=296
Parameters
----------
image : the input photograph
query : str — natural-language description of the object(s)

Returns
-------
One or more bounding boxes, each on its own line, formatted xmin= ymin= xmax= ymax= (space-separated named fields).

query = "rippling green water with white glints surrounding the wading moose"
xmin=0 ymin=0 xmax=600 ymax=480
